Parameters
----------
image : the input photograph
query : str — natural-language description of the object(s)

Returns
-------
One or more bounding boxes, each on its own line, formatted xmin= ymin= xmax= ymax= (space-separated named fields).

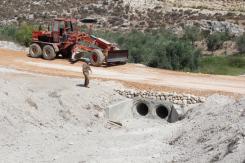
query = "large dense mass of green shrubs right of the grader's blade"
xmin=95 ymin=29 xmax=200 ymax=71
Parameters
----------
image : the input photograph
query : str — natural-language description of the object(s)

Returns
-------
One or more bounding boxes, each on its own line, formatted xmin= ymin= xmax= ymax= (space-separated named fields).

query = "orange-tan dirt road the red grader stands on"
xmin=0 ymin=49 xmax=245 ymax=95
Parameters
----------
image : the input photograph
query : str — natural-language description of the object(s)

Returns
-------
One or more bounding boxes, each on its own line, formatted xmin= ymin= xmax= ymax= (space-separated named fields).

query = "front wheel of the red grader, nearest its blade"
xmin=90 ymin=49 xmax=105 ymax=67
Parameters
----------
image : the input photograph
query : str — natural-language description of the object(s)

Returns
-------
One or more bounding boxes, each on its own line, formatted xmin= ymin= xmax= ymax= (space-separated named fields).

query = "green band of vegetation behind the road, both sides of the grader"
xmin=0 ymin=24 xmax=245 ymax=75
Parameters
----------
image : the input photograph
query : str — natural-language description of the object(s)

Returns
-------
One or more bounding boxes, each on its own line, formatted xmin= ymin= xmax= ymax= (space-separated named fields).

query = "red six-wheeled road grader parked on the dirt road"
xmin=29 ymin=18 xmax=128 ymax=66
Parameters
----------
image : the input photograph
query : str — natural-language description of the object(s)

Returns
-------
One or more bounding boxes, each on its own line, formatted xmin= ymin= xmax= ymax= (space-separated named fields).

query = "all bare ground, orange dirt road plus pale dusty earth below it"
xmin=0 ymin=42 xmax=245 ymax=163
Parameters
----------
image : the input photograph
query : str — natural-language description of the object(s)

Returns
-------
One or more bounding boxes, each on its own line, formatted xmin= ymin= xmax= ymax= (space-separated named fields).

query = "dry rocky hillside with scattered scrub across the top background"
xmin=0 ymin=0 xmax=245 ymax=34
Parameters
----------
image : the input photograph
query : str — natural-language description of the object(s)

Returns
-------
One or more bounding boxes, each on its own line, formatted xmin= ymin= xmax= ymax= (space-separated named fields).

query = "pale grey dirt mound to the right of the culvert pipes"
xmin=171 ymin=95 xmax=245 ymax=162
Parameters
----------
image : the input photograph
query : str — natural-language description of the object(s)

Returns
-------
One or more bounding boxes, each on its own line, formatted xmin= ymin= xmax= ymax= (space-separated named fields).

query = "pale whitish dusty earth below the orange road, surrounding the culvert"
xmin=0 ymin=68 xmax=245 ymax=163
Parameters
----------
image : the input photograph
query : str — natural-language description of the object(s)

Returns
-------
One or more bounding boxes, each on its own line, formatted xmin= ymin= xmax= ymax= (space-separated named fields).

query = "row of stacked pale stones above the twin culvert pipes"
xmin=115 ymin=90 xmax=206 ymax=105
